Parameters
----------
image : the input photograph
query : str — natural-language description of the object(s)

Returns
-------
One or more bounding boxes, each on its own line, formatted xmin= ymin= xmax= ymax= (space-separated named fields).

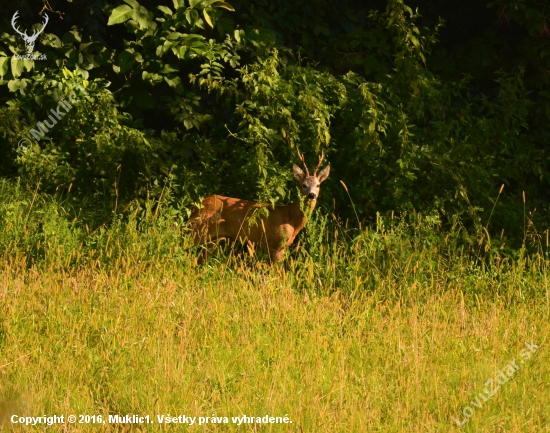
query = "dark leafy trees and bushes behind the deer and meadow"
xmin=0 ymin=0 xmax=550 ymax=243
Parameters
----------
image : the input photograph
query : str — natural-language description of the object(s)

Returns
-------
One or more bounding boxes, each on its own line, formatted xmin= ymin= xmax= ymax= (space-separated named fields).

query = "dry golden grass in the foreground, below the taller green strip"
xmin=0 ymin=251 xmax=550 ymax=433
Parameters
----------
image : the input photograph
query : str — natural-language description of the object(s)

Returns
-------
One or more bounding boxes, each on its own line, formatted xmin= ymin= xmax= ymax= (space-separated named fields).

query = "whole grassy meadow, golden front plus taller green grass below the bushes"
xmin=0 ymin=177 xmax=550 ymax=433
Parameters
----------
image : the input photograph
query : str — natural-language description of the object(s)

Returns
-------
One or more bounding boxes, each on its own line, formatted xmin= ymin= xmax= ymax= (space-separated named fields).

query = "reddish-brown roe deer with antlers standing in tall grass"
xmin=190 ymin=151 xmax=330 ymax=263
